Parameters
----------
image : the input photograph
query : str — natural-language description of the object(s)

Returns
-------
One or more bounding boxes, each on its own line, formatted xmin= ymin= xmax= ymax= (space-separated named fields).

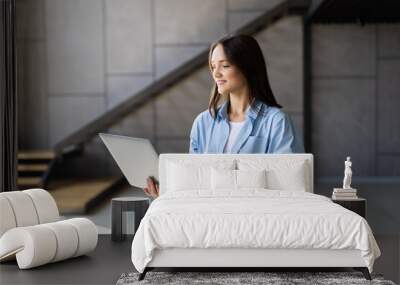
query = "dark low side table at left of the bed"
xmin=111 ymin=197 xmax=150 ymax=241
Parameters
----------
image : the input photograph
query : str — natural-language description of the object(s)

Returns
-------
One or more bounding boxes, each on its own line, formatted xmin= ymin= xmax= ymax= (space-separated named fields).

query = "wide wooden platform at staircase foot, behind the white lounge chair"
xmin=50 ymin=177 xmax=118 ymax=214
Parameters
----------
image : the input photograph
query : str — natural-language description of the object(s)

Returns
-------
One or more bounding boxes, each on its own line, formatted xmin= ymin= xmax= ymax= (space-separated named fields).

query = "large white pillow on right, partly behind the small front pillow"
xmin=237 ymin=159 xmax=310 ymax=191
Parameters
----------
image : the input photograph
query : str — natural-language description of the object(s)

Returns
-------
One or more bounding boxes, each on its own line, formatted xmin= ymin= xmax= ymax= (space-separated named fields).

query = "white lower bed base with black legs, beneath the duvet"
xmin=139 ymin=248 xmax=371 ymax=280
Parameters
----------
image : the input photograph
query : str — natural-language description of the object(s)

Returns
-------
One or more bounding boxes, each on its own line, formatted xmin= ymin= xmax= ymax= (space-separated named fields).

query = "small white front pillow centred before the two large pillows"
xmin=211 ymin=168 xmax=267 ymax=190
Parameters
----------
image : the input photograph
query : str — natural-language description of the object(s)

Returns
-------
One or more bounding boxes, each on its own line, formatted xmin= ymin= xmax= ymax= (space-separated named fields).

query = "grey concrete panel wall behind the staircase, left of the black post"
xmin=17 ymin=0 xmax=303 ymax=176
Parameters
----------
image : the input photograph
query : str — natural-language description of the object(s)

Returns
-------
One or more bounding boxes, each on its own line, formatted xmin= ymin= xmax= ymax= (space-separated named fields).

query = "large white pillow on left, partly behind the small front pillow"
xmin=167 ymin=160 xmax=235 ymax=191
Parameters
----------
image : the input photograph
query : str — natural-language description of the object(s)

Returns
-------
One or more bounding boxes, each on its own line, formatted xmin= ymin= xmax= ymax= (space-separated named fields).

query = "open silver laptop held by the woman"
xmin=99 ymin=133 xmax=158 ymax=188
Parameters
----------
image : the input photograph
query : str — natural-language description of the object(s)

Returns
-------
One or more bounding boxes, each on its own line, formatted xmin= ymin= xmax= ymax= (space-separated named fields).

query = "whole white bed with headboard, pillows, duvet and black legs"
xmin=132 ymin=154 xmax=380 ymax=280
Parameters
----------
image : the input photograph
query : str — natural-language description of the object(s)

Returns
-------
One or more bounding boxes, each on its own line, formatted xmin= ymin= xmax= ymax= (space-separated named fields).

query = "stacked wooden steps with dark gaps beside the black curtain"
xmin=17 ymin=150 xmax=56 ymax=190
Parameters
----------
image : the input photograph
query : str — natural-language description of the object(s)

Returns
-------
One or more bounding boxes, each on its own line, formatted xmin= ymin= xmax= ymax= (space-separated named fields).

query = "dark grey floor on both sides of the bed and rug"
xmin=0 ymin=235 xmax=400 ymax=285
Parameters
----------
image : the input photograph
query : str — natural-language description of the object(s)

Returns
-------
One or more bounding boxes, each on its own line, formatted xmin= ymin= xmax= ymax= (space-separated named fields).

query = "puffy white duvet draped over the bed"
xmin=132 ymin=189 xmax=380 ymax=272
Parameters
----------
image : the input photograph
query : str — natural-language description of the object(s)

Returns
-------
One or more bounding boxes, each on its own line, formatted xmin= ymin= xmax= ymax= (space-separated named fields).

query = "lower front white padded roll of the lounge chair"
xmin=0 ymin=218 xmax=98 ymax=269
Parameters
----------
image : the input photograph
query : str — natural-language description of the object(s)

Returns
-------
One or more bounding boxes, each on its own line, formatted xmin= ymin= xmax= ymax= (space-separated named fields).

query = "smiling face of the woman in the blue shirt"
xmin=211 ymin=44 xmax=247 ymax=94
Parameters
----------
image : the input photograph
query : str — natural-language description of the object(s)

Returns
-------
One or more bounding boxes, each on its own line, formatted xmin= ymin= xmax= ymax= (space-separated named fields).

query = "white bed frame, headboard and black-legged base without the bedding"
xmin=139 ymin=154 xmax=371 ymax=280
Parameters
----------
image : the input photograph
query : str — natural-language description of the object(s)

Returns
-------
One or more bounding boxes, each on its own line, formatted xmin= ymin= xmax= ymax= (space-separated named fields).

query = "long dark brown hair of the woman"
xmin=208 ymin=35 xmax=282 ymax=117
